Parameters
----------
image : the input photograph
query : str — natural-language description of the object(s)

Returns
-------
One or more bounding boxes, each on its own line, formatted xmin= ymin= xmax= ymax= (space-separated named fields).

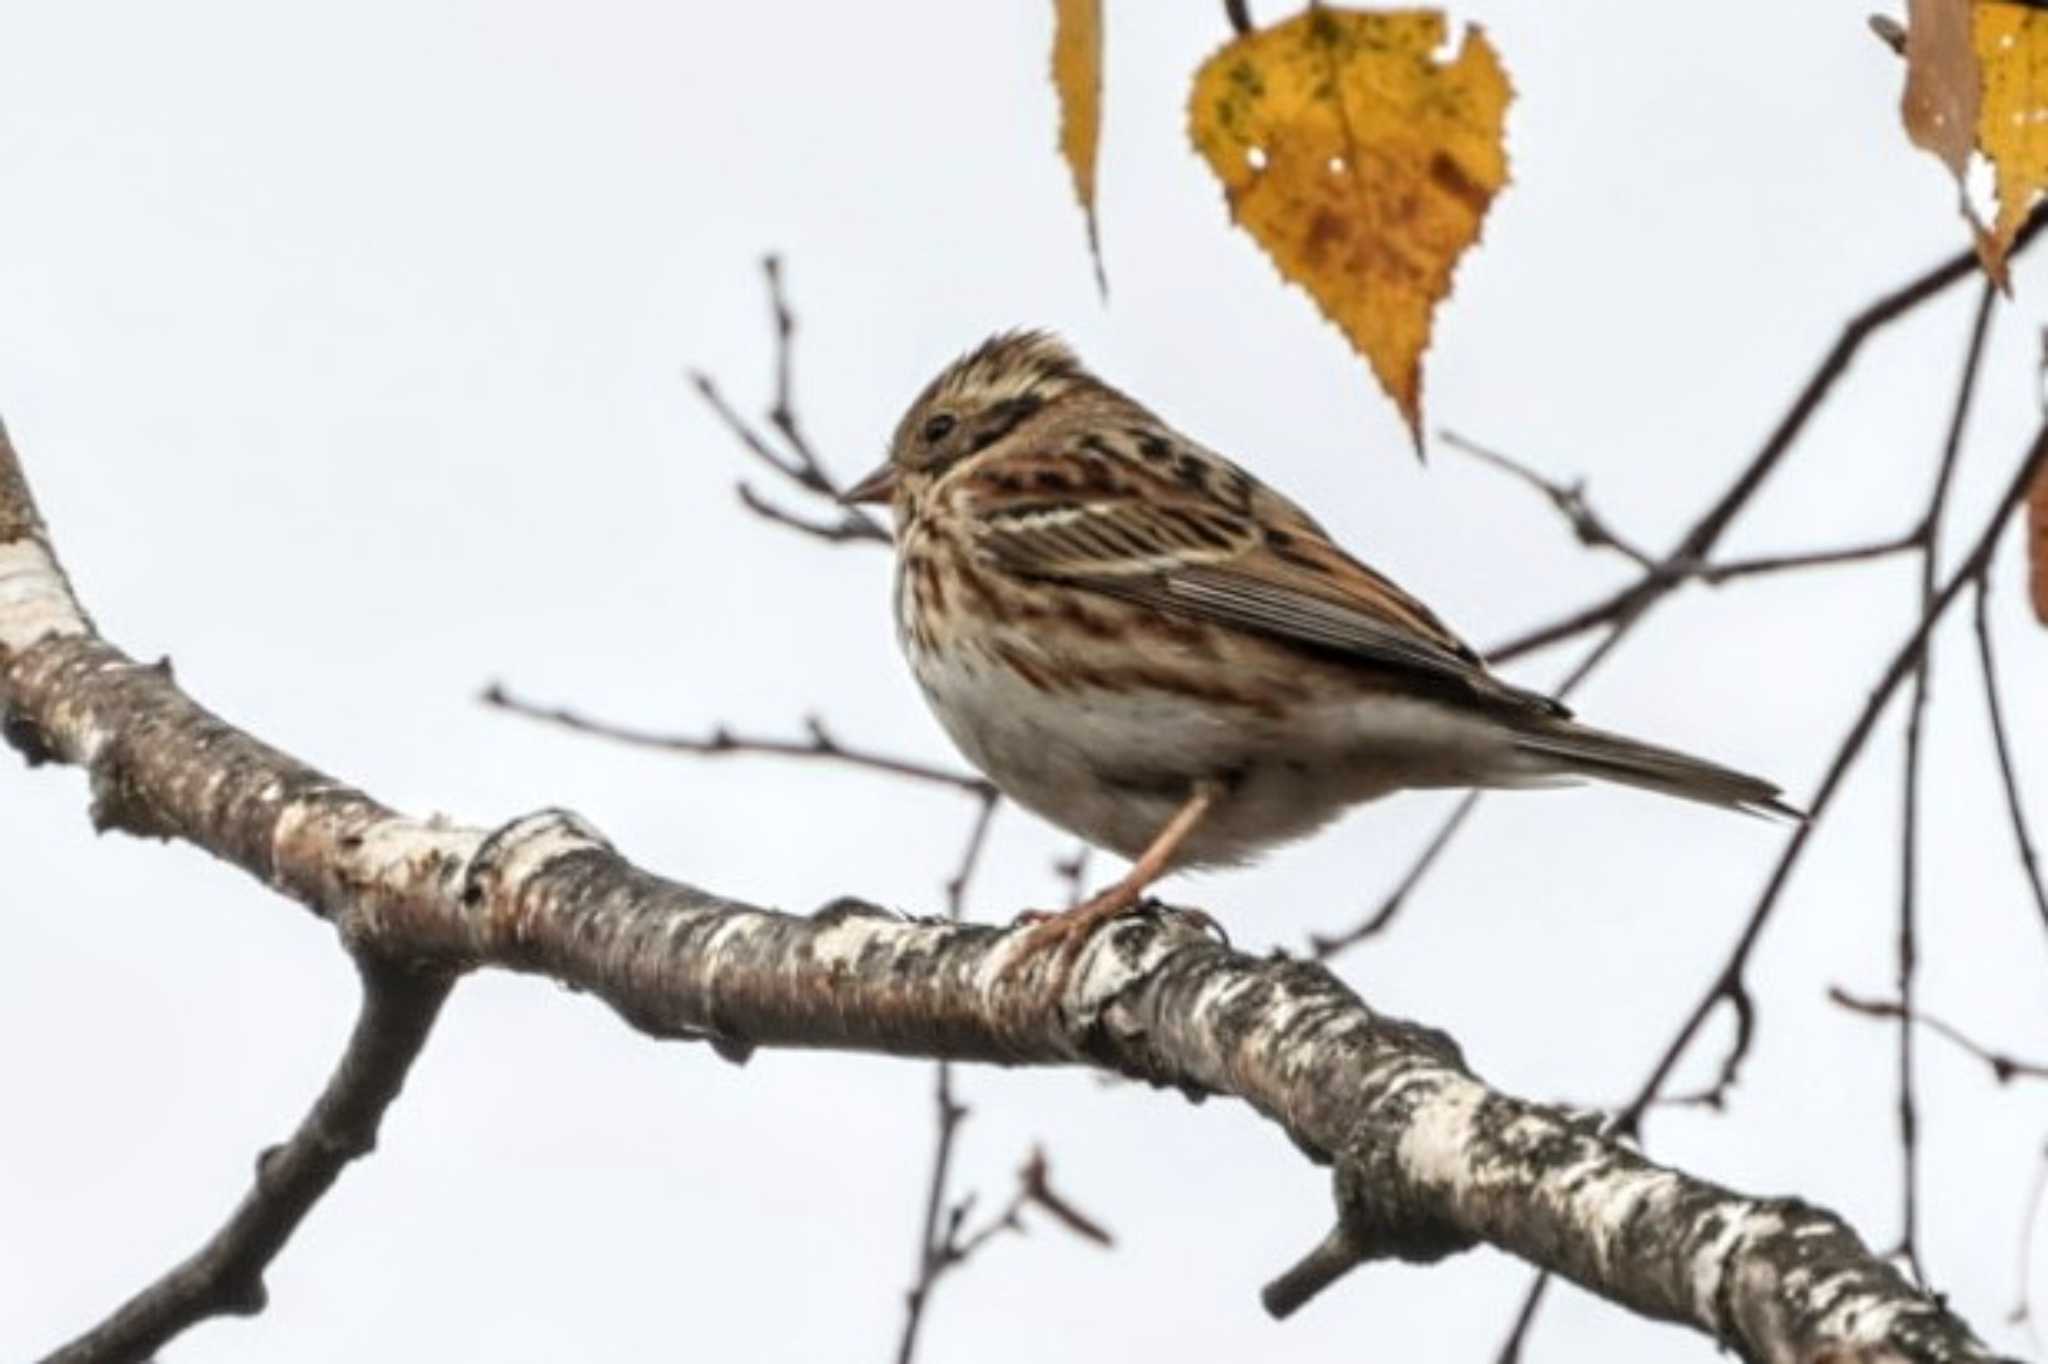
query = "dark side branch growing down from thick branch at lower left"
xmin=45 ymin=956 xmax=453 ymax=1364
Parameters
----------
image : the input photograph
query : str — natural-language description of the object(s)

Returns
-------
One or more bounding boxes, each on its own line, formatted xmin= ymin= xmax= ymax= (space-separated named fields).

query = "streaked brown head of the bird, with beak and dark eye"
xmin=842 ymin=332 xmax=1100 ymax=510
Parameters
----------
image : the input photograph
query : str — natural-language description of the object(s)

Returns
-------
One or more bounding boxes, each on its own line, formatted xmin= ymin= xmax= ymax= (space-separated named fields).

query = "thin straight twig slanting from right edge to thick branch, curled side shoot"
xmin=1616 ymin=426 xmax=2048 ymax=1135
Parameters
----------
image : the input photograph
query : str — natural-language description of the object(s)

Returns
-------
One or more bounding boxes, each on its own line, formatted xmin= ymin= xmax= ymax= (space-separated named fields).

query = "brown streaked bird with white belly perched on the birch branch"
xmin=842 ymin=330 xmax=1802 ymax=966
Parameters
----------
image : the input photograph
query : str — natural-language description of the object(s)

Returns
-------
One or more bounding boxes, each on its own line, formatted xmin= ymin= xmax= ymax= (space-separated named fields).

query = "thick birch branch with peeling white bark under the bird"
xmin=0 ymin=417 xmax=1993 ymax=1364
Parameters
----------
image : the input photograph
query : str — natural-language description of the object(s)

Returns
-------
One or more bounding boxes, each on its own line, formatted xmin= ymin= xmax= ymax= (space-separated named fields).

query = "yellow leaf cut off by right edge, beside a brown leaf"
xmin=1972 ymin=0 xmax=2048 ymax=283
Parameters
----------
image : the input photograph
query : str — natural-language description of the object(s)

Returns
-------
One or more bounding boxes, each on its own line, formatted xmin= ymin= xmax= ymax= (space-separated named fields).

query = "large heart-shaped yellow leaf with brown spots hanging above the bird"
xmin=1188 ymin=8 xmax=1511 ymax=451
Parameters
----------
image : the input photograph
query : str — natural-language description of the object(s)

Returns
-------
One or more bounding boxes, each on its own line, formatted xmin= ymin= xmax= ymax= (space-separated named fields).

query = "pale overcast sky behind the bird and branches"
xmin=0 ymin=0 xmax=2048 ymax=1364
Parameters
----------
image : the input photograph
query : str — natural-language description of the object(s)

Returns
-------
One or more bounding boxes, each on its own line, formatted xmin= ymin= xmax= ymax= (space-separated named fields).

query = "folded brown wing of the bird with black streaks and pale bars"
xmin=971 ymin=438 xmax=1565 ymax=715
